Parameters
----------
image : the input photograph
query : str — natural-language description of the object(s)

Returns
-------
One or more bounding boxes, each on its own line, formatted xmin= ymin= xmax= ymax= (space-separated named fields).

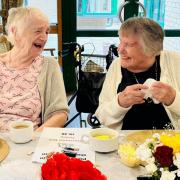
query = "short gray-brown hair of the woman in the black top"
xmin=118 ymin=17 xmax=164 ymax=56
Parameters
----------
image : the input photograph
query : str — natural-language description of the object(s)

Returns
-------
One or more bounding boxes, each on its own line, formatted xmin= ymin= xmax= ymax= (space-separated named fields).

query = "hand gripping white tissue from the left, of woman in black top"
xmin=118 ymin=84 xmax=148 ymax=108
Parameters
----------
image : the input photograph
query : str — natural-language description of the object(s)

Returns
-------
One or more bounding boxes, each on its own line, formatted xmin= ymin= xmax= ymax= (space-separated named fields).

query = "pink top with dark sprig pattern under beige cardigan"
xmin=0 ymin=56 xmax=43 ymax=132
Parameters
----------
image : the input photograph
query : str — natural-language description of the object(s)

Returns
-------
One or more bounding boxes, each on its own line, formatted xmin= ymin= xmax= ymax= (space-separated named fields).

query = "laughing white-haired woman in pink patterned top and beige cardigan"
xmin=0 ymin=7 xmax=69 ymax=132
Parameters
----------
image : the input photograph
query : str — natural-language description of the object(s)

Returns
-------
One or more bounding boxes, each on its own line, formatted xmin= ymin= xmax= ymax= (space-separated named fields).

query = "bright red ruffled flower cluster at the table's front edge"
xmin=41 ymin=153 xmax=107 ymax=180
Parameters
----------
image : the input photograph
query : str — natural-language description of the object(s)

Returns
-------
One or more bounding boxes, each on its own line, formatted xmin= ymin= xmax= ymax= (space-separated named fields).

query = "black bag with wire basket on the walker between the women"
xmin=76 ymin=54 xmax=106 ymax=113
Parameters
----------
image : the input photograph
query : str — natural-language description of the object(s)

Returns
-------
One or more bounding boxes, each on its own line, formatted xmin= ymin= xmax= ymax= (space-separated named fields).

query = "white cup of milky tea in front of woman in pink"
xmin=10 ymin=120 xmax=33 ymax=143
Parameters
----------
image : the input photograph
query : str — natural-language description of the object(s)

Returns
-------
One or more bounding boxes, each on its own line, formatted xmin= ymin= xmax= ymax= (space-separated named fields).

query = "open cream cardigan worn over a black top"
xmin=95 ymin=51 xmax=180 ymax=129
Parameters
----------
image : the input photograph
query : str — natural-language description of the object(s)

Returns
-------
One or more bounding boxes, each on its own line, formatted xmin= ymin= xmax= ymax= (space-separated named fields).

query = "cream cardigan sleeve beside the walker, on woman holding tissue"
xmin=95 ymin=59 xmax=129 ymax=129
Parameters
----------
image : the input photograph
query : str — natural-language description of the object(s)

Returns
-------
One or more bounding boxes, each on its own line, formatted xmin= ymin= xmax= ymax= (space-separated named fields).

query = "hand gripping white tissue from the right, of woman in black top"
xmin=151 ymin=82 xmax=176 ymax=106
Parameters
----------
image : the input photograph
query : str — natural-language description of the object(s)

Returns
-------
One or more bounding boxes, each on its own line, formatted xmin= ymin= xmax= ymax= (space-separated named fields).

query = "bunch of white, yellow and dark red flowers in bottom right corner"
xmin=136 ymin=132 xmax=180 ymax=180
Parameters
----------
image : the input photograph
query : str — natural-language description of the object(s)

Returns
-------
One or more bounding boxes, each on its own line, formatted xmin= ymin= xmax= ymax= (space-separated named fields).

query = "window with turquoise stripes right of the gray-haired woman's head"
xmin=144 ymin=0 xmax=180 ymax=51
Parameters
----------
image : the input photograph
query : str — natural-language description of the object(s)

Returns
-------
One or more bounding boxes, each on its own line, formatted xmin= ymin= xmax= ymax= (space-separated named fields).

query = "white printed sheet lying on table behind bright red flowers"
xmin=32 ymin=128 xmax=95 ymax=163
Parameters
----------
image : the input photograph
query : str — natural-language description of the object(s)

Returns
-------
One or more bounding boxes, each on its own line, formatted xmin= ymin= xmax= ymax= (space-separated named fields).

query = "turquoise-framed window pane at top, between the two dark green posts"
xmin=76 ymin=0 xmax=121 ymax=29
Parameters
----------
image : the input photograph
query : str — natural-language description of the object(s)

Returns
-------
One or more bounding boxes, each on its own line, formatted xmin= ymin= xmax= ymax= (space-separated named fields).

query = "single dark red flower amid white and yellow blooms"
xmin=154 ymin=146 xmax=173 ymax=167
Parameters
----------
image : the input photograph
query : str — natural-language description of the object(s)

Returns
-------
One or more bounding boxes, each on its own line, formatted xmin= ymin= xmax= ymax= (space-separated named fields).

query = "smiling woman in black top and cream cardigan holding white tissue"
xmin=95 ymin=17 xmax=180 ymax=130
